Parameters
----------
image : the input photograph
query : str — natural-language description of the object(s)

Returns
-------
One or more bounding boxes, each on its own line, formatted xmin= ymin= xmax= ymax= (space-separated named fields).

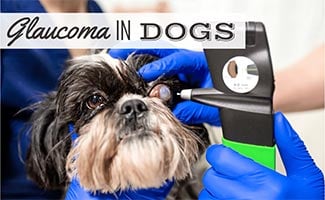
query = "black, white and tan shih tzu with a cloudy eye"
xmin=26 ymin=50 xmax=207 ymax=196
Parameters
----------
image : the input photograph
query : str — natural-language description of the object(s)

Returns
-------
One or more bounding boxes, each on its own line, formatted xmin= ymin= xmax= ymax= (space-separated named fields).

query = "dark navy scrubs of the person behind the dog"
xmin=1 ymin=0 xmax=102 ymax=199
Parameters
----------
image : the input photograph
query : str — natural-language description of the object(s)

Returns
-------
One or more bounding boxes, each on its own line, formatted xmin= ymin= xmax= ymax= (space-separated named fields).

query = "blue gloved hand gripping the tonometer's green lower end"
xmin=199 ymin=113 xmax=324 ymax=199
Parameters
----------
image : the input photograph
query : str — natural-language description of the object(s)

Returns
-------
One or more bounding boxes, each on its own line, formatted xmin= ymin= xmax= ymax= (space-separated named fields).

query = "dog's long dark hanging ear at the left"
xmin=26 ymin=92 xmax=71 ymax=189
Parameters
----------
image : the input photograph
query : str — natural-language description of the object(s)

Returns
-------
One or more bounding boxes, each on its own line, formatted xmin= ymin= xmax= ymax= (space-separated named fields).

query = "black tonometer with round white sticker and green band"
xmin=180 ymin=22 xmax=275 ymax=169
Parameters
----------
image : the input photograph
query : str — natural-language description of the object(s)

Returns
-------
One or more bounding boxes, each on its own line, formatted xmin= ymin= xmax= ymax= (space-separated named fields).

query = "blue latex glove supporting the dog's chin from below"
xmin=65 ymin=124 xmax=174 ymax=200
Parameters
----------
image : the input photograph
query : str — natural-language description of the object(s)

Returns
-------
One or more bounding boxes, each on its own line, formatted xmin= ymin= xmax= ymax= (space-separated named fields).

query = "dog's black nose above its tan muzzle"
xmin=120 ymin=99 xmax=148 ymax=118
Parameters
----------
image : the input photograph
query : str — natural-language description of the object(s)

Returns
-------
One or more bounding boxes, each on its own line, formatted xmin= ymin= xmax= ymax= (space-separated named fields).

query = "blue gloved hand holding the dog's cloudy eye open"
xmin=109 ymin=49 xmax=220 ymax=126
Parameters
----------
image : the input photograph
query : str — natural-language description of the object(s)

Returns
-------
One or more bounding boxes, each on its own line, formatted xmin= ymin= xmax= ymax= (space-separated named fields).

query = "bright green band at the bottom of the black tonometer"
xmin=222 ymin=138 xmax=275 ymax=170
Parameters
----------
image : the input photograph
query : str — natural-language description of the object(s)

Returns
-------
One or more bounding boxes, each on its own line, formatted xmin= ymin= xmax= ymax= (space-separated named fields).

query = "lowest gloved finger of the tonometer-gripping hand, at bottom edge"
xmin=202 ymin=167 xmax=249 ymax=199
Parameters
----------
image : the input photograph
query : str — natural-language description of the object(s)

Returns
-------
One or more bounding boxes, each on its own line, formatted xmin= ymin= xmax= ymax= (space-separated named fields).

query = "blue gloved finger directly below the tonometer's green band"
xmin=206 ymin=145 xmax=266 ymax=178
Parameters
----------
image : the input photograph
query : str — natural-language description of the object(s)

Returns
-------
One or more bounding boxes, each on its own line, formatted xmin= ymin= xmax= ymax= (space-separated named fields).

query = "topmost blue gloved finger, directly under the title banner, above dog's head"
xmin=108 ymin=49 xmax=179 ymax=60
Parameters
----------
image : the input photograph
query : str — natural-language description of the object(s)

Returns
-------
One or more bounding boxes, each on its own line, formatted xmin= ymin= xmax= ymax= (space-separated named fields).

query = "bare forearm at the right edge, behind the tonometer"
xmin=274 ymin=45 xmax=324 ymax=112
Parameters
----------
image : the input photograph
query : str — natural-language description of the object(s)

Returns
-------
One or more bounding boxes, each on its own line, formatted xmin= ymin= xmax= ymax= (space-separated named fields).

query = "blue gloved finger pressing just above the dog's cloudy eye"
xmin=139 ymin=50 xmax=206 ymax=81
